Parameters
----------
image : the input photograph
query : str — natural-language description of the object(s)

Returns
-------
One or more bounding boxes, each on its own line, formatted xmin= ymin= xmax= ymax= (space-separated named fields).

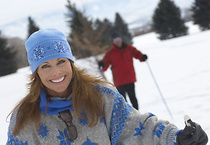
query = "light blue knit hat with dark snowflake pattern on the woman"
xmin=25 ymin=29 xmax=74 ymax=73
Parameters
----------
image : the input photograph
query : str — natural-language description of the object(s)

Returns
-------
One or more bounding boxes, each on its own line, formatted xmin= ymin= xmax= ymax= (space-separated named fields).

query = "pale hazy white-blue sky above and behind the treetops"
xmin=0 ymin=0 xmax=194 ymax=36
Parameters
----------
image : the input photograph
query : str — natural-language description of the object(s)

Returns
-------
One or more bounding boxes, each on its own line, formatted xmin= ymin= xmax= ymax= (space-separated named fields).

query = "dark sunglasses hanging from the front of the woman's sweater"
xmin=58 ymin=110 xmax=78 ymax=140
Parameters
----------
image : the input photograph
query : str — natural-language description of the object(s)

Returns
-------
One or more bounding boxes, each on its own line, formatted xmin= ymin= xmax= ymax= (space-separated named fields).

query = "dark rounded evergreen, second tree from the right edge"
xmin=152 ymin=0 xmax=188 ymax=40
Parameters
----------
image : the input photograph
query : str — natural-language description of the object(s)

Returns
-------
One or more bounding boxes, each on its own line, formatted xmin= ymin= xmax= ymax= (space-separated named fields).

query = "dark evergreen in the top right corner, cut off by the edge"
xmin=192 ymin=0 xmax=210 ymax=31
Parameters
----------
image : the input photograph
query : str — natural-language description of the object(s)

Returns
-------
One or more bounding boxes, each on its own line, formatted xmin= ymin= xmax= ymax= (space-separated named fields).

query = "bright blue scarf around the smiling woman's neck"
xmin=39 ymin=89 xmax=73 ymax=115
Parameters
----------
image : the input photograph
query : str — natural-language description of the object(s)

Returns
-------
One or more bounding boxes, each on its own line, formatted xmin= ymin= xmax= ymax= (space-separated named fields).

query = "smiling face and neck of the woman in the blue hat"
xmin=37 ymin=58 xmax=72 ymax=97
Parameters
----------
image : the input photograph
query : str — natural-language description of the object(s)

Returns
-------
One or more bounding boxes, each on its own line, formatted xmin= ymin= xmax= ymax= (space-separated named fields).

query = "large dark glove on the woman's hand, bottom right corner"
xmin=176 ymin=120 xmax=208 ymax=145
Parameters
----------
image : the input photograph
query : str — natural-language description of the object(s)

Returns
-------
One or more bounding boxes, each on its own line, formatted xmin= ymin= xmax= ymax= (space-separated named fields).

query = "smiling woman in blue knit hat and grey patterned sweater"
xmin=7 ymin=29 xmax=208 ymax=145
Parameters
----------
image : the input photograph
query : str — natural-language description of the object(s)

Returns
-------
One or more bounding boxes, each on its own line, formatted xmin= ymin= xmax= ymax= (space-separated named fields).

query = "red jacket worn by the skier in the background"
xmin=103 ymin=44 xmax=143 ymax=86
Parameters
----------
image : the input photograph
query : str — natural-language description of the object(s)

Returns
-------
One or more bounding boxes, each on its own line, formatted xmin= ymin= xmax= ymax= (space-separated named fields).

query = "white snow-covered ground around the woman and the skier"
xmin=0 ymin=23 xmax=210 ymax=144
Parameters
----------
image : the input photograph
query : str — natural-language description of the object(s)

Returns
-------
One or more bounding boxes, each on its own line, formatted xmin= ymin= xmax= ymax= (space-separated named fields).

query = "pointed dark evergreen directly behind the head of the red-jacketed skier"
xmin=114 ymin=13 xmax=132 ymax=44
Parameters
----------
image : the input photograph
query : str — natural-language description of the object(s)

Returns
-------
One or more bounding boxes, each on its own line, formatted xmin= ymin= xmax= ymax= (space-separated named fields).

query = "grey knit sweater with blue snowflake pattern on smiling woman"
xmin=7 ymin=86 xmax=180 ymax=145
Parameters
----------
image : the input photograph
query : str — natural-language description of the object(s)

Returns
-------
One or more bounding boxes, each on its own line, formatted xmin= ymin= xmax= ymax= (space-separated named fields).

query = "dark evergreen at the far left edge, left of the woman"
xmin=0 ymin=32 xmax=17 ymax=76
